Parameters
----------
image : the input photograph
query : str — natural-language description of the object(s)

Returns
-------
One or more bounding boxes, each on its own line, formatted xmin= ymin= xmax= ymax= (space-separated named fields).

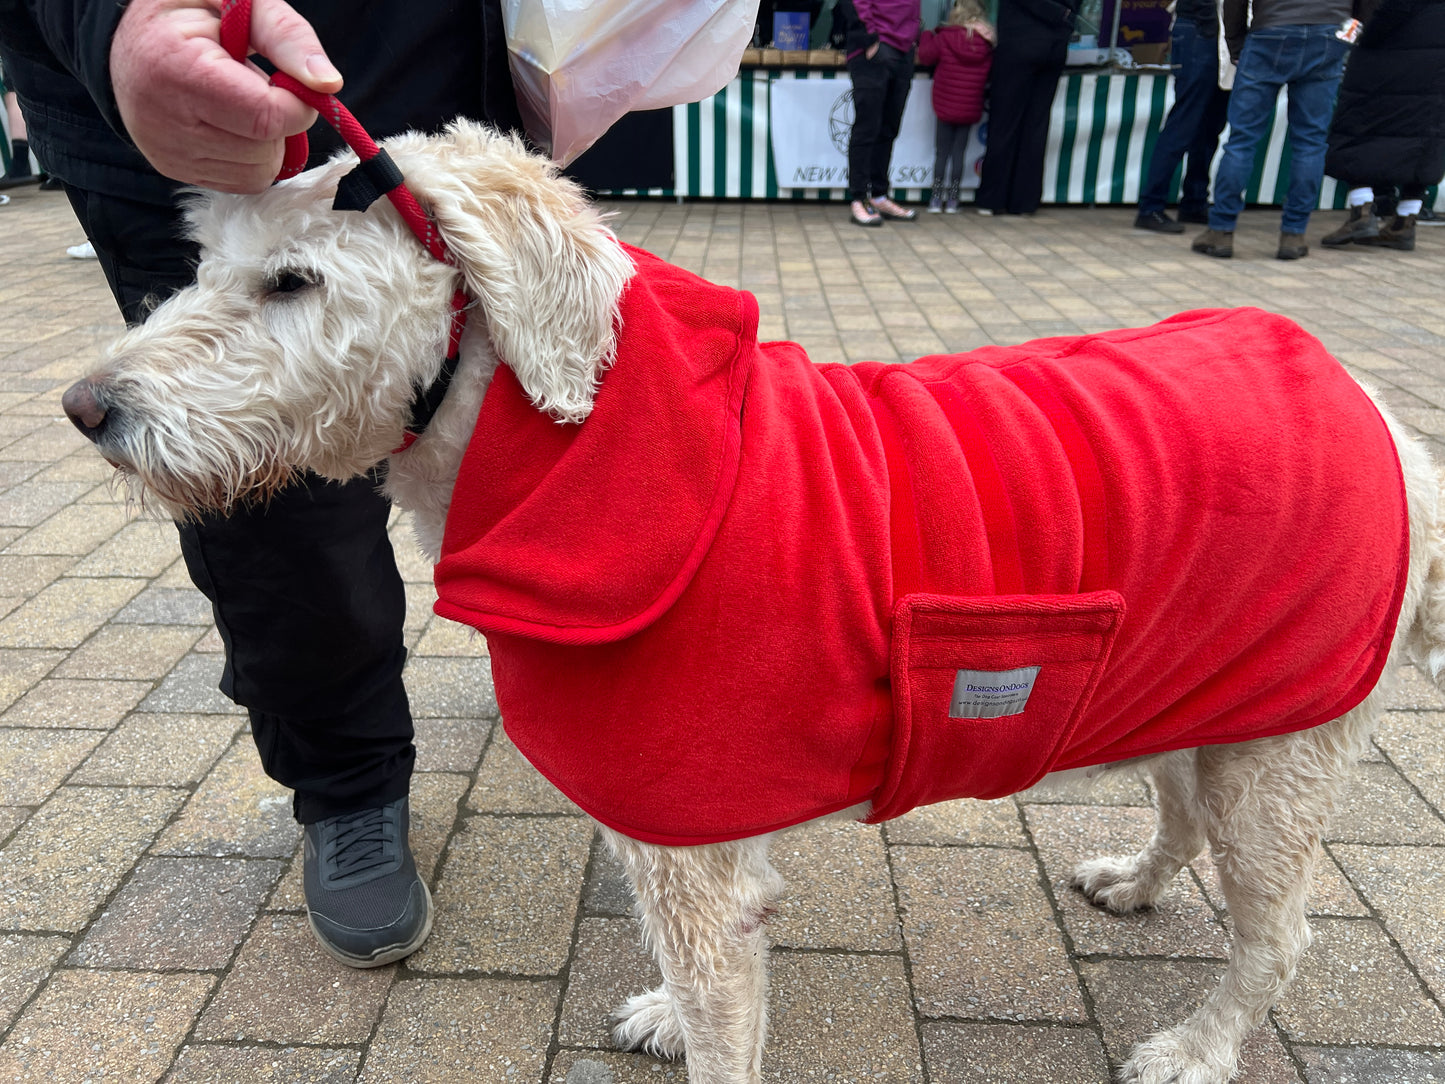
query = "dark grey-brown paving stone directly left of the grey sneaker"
xmin=69 ymin=859 xmax=280 ymax=971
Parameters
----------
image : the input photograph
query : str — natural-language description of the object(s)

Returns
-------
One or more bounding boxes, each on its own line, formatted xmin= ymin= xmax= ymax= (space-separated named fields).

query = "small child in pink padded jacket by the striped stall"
xmin=918 ymin=0 xmax=996 ymax=214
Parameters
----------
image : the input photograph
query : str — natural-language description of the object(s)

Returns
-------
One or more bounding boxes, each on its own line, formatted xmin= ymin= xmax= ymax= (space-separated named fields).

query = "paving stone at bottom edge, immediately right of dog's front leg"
xmin=763 ymin=952 xmax=923 ymax=1084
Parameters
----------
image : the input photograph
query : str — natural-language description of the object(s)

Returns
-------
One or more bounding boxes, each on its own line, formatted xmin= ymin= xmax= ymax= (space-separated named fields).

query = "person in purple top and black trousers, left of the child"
xmin=834 ymin=0 xmax=919 ymax=225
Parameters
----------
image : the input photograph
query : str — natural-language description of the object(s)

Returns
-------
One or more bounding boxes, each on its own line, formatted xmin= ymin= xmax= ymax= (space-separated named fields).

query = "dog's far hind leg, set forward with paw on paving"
xmin=1074 ymin=749 xmax=1205 ymax=915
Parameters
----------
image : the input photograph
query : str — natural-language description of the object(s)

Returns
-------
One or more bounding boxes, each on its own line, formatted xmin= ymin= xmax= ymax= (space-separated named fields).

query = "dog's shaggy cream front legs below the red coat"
xmin=604 ymin=830 xmax=783 ymax=1084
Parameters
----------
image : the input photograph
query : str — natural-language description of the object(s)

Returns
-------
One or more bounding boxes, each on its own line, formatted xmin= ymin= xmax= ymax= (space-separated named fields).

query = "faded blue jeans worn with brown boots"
xmin=1209 ymin=23 xmax=1350 ymax=233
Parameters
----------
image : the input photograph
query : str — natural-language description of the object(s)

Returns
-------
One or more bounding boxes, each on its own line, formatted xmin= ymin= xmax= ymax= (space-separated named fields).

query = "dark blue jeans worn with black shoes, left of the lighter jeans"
xmin=1139 ymin=20 xmax=1230 ymax=214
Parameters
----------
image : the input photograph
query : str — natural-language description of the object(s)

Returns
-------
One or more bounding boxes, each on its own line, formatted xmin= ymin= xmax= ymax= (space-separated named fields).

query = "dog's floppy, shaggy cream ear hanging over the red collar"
xmin=389 ymin=121 xmax=633 ymax=422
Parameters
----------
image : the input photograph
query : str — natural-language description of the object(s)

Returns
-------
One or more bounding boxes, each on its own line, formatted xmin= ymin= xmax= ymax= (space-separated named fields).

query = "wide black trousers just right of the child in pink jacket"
xmin=975 ymin=38 xmax=1068 ymax=214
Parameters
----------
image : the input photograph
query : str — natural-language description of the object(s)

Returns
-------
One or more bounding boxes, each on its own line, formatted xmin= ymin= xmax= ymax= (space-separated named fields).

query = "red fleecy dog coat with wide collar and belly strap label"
xmin=436 ymin=250 xmax=1407 ymax=844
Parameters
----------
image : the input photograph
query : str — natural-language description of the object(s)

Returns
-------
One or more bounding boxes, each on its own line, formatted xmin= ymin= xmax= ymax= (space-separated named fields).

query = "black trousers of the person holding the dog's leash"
xmin=66 ymin=186 xmax=416 ymax=824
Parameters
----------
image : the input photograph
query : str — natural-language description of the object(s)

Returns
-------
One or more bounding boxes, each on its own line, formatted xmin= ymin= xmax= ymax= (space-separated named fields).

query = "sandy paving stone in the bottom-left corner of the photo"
xmin=0 ymin=971 xmax=215 ymax=1084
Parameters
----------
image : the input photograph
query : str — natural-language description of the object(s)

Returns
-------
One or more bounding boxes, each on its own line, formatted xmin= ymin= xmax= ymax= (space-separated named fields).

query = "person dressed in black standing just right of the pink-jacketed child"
xmin=975 ymin=0 xmax=1078 ymax=214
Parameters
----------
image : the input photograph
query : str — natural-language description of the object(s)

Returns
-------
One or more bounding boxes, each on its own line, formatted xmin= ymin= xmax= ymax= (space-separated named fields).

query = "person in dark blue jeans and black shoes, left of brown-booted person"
xmin=1134 ymin=0 xmax=1230 ymax=233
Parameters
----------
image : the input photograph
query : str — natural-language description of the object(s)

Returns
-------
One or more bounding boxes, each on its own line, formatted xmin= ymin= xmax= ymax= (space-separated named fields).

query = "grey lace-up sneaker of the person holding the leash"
xmin=305 ymin=798 xmax=432 ymax=967
